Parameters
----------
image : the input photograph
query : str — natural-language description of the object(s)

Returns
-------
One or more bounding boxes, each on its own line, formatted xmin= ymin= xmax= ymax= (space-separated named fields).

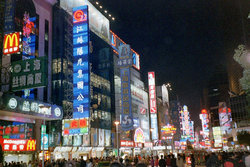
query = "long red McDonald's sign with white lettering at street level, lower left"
xmin=0 ymin=139 xmax=36 ymax=151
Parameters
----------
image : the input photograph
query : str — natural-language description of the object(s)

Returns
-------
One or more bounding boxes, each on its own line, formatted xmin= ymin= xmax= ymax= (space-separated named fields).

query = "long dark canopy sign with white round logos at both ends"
xmin=0 ymin=95 xmax=63 ymax=120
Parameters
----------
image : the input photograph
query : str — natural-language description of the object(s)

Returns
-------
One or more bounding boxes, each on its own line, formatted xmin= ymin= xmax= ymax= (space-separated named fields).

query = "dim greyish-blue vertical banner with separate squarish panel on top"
xmin=118 ymin=45 xmax=134 ymax=131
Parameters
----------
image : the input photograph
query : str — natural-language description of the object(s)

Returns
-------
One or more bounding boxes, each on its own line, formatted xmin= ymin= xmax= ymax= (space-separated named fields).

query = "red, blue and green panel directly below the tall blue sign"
xmin=62 ymin=118 xmax=89 ymax=136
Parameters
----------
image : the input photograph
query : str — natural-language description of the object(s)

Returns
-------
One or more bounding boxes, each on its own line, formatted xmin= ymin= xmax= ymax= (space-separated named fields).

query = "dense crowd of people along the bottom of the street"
xmin=3 ymin=152 xmax=250 ymax=167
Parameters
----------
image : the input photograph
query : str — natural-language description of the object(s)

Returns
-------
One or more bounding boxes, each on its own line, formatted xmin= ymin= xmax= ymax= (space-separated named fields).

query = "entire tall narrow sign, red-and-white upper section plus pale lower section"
xmin=148 ymin=72 xmax=159 ymax=140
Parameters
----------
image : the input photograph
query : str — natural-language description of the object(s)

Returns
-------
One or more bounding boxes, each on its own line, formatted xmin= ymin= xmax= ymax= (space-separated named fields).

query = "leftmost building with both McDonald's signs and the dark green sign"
xmin=0 ymin=0 xmax=63 ymax=162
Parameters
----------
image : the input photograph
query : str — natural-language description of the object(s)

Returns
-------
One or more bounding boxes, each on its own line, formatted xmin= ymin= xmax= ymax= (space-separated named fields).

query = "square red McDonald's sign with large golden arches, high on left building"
xmin=3 ymin=32 xmax=21 ymax=55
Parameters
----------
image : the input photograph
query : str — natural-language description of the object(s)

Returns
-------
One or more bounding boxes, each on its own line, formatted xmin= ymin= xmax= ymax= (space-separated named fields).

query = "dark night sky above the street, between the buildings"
xmin=95 ymin=0 xmax=248 ymax=124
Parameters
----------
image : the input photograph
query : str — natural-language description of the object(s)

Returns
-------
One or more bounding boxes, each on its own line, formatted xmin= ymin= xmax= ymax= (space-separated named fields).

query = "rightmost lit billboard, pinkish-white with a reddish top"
xmin=219 ymin=102 xmax=232 ymax=135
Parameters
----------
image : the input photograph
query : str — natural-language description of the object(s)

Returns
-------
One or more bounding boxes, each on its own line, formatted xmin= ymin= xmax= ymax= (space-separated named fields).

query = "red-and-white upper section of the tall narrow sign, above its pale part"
xmin=148 ymin=72 xmax=157 ymax=114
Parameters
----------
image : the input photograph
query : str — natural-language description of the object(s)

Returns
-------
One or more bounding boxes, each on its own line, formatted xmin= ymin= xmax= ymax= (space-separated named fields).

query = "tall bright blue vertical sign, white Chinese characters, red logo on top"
xmin=73 ymin=6 xmax=90 ymax=118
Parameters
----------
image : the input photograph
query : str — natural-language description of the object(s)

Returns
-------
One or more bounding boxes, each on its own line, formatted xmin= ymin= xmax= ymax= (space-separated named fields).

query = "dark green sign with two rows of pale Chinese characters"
xmin=11 ymin=57 xmax=48 ymax=91
